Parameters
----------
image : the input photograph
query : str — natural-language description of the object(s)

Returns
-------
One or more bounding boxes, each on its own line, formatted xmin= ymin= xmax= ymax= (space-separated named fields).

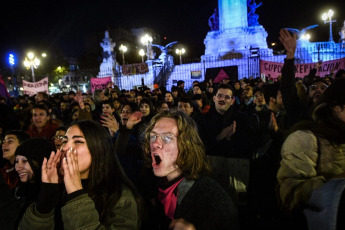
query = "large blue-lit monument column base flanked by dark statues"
xmin=203 ymin=0 xmax=272 ymax=58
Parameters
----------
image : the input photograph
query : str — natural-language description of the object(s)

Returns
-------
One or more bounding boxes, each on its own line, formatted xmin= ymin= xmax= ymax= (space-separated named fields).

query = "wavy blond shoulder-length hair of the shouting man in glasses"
xmin=142 ymin=110 xmax=210 ymax=180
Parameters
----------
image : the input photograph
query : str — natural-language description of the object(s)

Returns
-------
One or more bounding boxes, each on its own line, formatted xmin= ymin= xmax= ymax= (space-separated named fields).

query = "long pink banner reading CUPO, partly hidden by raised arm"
xmin=260 ymin=58 xmax=345 ymax=78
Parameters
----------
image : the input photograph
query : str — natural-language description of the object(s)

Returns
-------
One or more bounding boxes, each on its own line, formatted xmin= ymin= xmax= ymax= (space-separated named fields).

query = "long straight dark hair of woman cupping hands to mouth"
xmin=71 ymin=120 xmax=142 ymax=221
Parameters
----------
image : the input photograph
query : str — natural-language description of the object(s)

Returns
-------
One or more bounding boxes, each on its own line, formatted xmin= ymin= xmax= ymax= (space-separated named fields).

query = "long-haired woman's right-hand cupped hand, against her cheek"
xmin=62 ymin=148 xmax=83 ymax=194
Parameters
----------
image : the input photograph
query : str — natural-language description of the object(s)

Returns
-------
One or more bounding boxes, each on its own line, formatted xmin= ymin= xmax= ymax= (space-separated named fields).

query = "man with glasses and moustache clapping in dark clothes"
xmin=199 ymin=84 xmax=258 ymax=223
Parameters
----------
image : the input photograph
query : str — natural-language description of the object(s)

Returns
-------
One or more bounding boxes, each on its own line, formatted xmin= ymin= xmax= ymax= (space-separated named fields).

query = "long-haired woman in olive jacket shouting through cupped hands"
xmin=19 ymin=121 xmax=140 ymax=229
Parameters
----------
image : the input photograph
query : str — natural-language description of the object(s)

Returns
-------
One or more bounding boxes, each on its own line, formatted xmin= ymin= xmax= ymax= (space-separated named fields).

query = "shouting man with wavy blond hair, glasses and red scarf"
xmin=143 ymin=110 xmax=239 ymax=230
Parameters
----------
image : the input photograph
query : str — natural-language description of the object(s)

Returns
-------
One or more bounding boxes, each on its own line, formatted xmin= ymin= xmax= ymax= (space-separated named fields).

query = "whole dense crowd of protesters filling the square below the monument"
xmin=0 ymin=29 xmax=345 ymax=230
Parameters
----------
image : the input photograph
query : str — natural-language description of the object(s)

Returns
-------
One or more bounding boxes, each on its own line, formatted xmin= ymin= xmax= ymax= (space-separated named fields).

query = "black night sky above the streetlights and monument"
xmin=0 ymin=0 xmax=345 ymax=66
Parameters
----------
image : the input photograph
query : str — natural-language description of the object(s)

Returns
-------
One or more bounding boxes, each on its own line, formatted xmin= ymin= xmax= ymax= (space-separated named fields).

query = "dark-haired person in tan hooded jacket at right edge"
xmin=277 ymin=80 xmax=345 ymax=228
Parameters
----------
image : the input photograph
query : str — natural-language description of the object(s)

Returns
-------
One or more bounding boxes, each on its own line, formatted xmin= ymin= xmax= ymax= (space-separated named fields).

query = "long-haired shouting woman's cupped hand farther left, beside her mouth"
xmin=42 ymin=150 xmax=61 ymax=184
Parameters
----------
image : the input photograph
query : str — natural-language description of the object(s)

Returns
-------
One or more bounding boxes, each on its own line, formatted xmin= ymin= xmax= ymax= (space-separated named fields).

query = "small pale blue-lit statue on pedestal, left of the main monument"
xmin=97 ymin=31 xmax=116 ymax=80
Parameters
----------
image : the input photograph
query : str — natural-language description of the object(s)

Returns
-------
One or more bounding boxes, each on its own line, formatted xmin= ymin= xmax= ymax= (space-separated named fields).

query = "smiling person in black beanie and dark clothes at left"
xmin=0 ymin=138 xmax=53 ymax=229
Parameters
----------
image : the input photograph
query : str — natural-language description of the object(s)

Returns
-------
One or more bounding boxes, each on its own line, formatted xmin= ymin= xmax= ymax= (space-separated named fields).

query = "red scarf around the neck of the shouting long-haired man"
xmin=158 ymin=177 xmax=184 ymax=219
